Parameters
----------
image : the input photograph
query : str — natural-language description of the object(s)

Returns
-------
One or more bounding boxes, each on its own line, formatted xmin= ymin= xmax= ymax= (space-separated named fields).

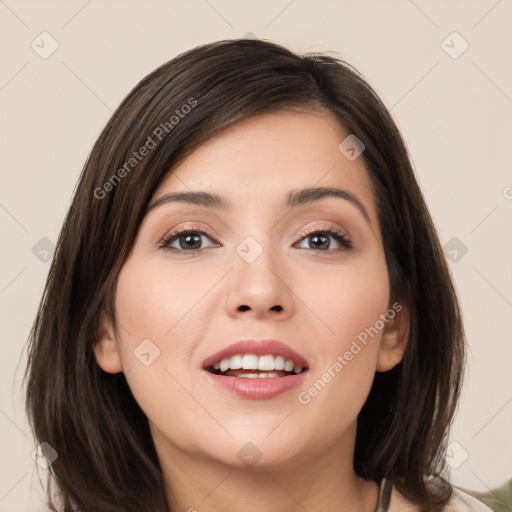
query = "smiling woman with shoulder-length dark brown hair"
xmin=27 ymin=40 xmax=487 ymax=512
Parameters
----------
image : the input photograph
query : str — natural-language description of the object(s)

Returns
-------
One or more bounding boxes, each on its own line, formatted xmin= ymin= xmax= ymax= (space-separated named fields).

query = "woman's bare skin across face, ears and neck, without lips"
xmin=95 ymin=111 xmax=412 ymax=512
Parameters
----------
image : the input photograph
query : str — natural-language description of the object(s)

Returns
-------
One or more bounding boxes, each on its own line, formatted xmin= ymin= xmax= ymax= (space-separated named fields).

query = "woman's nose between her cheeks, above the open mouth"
xmin=226 ymin=241 xmax=295 ymax=320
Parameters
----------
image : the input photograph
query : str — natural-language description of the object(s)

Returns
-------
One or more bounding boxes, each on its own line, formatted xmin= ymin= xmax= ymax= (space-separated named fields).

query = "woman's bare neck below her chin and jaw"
xmin=154 ymin=426 xmax=378 ymax=512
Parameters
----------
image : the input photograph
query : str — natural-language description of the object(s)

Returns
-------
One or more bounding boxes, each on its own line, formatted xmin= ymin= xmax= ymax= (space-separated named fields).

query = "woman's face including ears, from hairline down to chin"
xmin=95 ymin=111 xmax=405 ymax=474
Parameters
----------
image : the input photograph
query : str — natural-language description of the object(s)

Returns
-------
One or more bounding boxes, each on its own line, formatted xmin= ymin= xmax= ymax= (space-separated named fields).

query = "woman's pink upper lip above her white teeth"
xmin=203 ymin=339 xmax=309 ymax=369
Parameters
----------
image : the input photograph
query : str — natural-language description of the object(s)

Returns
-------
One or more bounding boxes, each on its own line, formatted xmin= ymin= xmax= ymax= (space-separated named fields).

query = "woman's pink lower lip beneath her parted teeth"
xmin=203 ymin=370 xmax=308 ymax=400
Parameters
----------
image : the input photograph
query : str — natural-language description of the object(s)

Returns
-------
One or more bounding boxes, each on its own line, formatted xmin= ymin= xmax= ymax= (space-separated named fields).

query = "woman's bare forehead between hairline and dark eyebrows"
xmin=150 ymin=110 xmax=376 ymax=222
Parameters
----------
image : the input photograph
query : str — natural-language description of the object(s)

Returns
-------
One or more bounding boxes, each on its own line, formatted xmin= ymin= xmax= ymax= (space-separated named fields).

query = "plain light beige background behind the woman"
xmin=0 ymin=0 xmax=512 ymax=512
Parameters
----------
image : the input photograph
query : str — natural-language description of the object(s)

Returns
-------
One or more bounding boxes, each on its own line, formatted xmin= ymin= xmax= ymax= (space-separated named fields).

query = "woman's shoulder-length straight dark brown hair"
xmin=26 ymin=39 xmax=465 ymax=512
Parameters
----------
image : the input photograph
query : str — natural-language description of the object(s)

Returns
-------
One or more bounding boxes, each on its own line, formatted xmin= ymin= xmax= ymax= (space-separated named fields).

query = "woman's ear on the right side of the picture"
xmin=377 ymin=302 xmax=410 ymax=372
